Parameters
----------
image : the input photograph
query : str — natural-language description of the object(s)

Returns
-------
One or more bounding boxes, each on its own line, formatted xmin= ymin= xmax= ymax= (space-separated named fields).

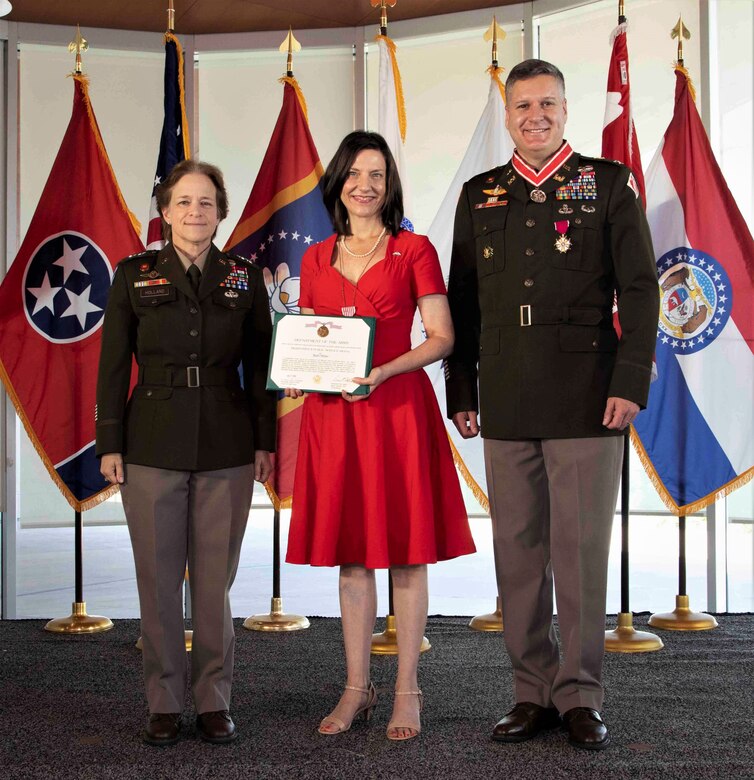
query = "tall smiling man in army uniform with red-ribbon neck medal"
xmin=446 ymin=60 xmax=659 ymax=750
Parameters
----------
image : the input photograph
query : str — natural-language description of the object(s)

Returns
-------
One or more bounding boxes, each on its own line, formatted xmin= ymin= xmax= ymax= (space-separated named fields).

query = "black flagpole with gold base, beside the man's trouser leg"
xmin=605 ymin=0 xmax=664 ymax=653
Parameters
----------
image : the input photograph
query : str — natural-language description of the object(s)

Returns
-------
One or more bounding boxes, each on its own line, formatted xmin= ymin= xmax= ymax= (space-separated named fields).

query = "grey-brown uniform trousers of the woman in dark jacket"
xmin=121 ymin=463 xmax=254 ymax=713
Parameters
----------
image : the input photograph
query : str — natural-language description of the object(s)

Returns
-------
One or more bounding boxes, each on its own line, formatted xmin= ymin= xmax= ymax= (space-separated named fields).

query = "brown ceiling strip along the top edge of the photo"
xmin=5 ymin=0 xmax=519 ymax=35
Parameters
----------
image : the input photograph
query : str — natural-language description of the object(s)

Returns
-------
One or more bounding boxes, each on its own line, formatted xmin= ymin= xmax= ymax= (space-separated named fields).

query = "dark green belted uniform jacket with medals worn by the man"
xmin=445 ymin=153 xmax=659 ymax=439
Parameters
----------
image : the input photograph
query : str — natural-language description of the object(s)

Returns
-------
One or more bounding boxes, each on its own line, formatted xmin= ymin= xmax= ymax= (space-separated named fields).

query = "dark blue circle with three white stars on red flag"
xmin=21 ymin=230 xmax=113 ymax=344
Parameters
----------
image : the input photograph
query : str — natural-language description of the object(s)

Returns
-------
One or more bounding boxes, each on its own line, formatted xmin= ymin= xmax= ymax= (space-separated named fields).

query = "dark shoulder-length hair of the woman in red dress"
xmin=322 ymin=130 xmax=403 ymax=236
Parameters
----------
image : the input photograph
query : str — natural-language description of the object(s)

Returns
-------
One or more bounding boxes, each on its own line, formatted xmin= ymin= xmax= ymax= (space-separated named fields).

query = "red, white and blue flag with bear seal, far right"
xmin=634 ymin=67 xmax=754 ymax=515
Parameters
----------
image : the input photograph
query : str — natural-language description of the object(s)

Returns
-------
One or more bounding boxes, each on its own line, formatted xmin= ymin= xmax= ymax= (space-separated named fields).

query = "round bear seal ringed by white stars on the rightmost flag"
xmin=657 ymin=247 xmax=732 ymax=355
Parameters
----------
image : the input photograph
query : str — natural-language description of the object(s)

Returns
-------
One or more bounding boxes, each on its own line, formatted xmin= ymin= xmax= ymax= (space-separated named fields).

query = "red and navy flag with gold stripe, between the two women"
xmin=225 ymin=77 xmax=333 ymax=509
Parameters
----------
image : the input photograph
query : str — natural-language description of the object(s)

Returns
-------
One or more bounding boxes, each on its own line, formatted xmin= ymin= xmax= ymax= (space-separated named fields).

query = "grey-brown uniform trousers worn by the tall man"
xmin=484 ymin=436 xmax=623 ymax=713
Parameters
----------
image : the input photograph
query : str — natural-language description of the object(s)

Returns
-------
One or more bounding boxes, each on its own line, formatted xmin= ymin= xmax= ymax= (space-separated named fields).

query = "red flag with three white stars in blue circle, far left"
xmin=0 ymin=76 xmax=143 ymax=511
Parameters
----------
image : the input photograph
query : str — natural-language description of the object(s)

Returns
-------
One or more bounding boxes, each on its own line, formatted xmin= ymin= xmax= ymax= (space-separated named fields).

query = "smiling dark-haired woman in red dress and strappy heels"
xmin=286 ymin=131 xmax=474 ymax=740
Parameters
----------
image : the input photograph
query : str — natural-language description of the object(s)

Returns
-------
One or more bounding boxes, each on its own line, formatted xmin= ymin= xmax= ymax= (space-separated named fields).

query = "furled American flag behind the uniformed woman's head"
xmin=147 ymin=33 xmax=191 ymax=249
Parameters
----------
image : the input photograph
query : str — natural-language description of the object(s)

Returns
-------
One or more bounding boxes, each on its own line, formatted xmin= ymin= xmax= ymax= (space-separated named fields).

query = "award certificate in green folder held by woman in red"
xmin=267 ymin=314 xmax=376 ymax=395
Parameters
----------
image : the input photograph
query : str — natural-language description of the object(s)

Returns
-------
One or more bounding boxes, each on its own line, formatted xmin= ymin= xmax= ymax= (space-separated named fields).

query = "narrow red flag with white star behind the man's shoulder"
xmin=602 ymin=17 xmax=647 ymax=206
